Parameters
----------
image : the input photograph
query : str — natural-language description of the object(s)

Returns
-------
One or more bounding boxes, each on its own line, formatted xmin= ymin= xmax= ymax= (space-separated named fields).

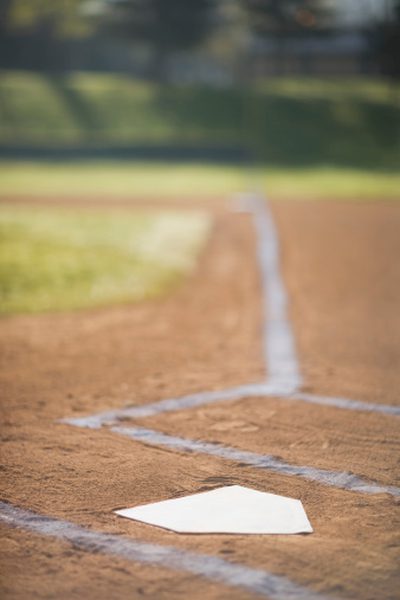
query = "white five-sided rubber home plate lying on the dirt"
xmin=114 ymin=485 xmax=313 ymax=534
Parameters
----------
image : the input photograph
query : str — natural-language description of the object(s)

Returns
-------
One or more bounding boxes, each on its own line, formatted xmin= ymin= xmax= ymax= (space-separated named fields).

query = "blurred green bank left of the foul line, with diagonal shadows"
xmin=0 ymin=72 xmax=240 ymax=146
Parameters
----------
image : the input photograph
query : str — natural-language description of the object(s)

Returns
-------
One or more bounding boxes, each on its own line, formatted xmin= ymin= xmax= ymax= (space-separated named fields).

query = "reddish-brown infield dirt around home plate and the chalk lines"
xmin=0 ymin=199 xmax=400 ymax=600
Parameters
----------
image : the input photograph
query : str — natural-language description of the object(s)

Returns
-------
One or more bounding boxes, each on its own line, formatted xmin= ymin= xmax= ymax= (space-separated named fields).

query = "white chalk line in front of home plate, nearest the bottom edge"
xmin=0 ymin=502 xmax=332 ymax=600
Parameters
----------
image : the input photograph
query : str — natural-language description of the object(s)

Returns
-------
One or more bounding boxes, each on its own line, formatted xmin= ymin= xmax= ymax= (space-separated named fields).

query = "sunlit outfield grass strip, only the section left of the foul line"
xmin=0 ymin=162 xmax=243 ymax=197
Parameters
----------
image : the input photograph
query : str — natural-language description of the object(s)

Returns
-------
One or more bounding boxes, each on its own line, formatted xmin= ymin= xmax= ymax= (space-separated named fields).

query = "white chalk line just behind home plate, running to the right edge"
xmin=111 ymin=427 xmax=400 ymax=497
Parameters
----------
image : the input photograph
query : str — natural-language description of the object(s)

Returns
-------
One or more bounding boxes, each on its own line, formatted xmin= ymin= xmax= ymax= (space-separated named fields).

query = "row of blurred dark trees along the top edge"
xmin=0 ymin=0 xmax=400 ymax=79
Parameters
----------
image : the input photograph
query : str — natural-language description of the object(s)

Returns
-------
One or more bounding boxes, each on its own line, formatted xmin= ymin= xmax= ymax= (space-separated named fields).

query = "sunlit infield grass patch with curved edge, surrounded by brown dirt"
xmin=0 ymin=206 xmax=210 ymax=315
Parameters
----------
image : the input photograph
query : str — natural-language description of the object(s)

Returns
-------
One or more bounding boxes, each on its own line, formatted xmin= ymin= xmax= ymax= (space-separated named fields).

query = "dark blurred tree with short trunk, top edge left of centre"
xmin=103 ymin=0 xmax=216 ymax=81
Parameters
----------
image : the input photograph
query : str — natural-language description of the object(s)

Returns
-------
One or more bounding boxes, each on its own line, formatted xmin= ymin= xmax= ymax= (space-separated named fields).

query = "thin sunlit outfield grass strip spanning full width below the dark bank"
xmin=0 ymin=162 xmax=400 ymax=201
